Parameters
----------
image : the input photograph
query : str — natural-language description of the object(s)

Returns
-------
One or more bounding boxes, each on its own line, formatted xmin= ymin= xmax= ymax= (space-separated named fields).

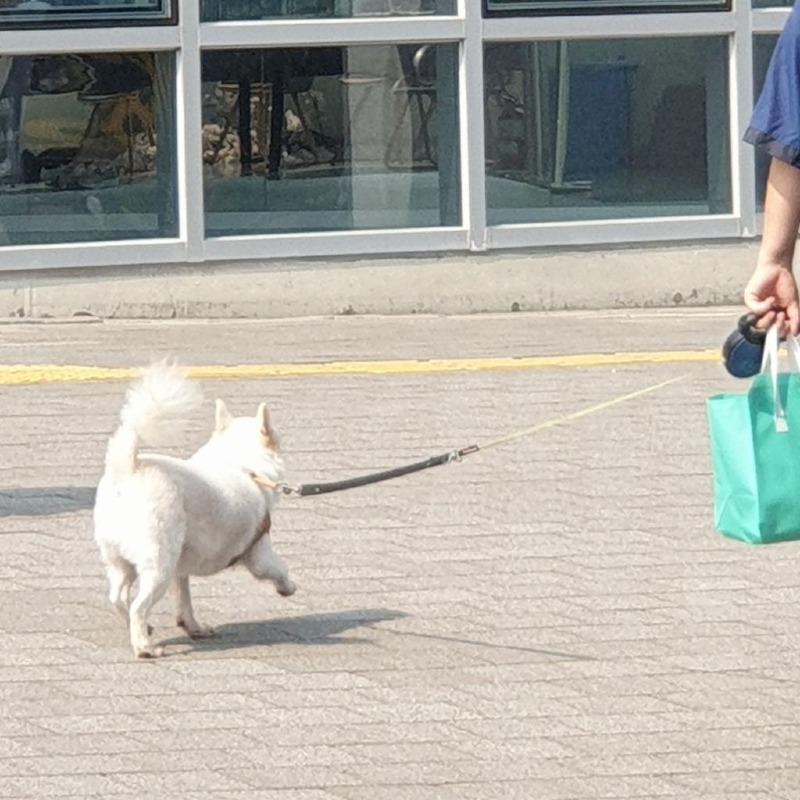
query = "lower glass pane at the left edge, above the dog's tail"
xmin=0 ymin=53 xmax=177 ymax=245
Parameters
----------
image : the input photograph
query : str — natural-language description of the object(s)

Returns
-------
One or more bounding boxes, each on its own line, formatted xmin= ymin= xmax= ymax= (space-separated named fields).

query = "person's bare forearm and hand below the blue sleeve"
xmin=744 ymin=158 xmax=800 ymax=336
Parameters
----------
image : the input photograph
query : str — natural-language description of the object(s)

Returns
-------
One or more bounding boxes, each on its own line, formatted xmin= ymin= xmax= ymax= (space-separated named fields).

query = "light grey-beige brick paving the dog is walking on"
xmin=0 ymin=309 xmax=800 ymax=800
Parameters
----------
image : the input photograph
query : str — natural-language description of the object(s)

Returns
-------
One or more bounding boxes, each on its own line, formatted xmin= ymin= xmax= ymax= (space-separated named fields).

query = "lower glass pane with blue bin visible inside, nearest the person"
xmin=485 ymin=37 xmax=731 ymax=224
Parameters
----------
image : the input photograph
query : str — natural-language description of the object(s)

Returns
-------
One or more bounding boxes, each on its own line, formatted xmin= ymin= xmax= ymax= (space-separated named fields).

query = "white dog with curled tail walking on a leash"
xmin=94 ymin=363 xmax=295 ymax=657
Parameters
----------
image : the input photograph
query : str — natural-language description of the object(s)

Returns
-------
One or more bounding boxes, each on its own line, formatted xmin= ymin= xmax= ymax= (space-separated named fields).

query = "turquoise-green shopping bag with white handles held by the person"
xmin=707 ymin=328 xmax=800 ymax=544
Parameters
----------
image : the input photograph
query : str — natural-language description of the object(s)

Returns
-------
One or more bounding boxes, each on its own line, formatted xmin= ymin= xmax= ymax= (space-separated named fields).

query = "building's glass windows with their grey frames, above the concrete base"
xmin=0 ymin=0 xmax=789 ymax=313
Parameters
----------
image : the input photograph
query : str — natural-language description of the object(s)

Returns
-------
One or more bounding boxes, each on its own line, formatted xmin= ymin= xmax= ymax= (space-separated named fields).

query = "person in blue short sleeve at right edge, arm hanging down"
xmin=744 ymin=4 xmax=800 ymax=336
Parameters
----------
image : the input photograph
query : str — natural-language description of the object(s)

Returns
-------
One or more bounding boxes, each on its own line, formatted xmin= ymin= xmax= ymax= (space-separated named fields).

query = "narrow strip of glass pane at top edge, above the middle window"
xmin=200 ymin=0 xmax=456 ymax=22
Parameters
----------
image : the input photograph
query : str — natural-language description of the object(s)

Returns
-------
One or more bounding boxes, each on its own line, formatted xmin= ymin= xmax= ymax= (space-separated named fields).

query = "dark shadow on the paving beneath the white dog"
xmin=161 ymin=608 xmax=408 ymax=652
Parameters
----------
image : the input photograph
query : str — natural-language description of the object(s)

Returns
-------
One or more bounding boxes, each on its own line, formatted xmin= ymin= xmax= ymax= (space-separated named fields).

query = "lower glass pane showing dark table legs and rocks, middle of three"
xmin=203 ymin=44 xmax=460 ymax=236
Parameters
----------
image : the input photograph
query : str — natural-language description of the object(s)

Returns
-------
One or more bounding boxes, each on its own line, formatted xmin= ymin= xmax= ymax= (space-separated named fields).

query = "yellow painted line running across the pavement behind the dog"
xmin=0 ymin=350 xmax=720 ymax=386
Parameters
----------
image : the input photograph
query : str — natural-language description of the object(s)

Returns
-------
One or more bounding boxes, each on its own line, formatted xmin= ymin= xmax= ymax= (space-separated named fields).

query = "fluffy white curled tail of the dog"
xmin=106 ymin=361 xmax=202 ymax=478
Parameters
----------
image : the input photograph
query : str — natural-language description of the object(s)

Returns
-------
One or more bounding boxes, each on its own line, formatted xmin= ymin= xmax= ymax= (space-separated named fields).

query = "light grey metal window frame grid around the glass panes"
xmin=0 ymin=0 xmax=790 ymax=270
